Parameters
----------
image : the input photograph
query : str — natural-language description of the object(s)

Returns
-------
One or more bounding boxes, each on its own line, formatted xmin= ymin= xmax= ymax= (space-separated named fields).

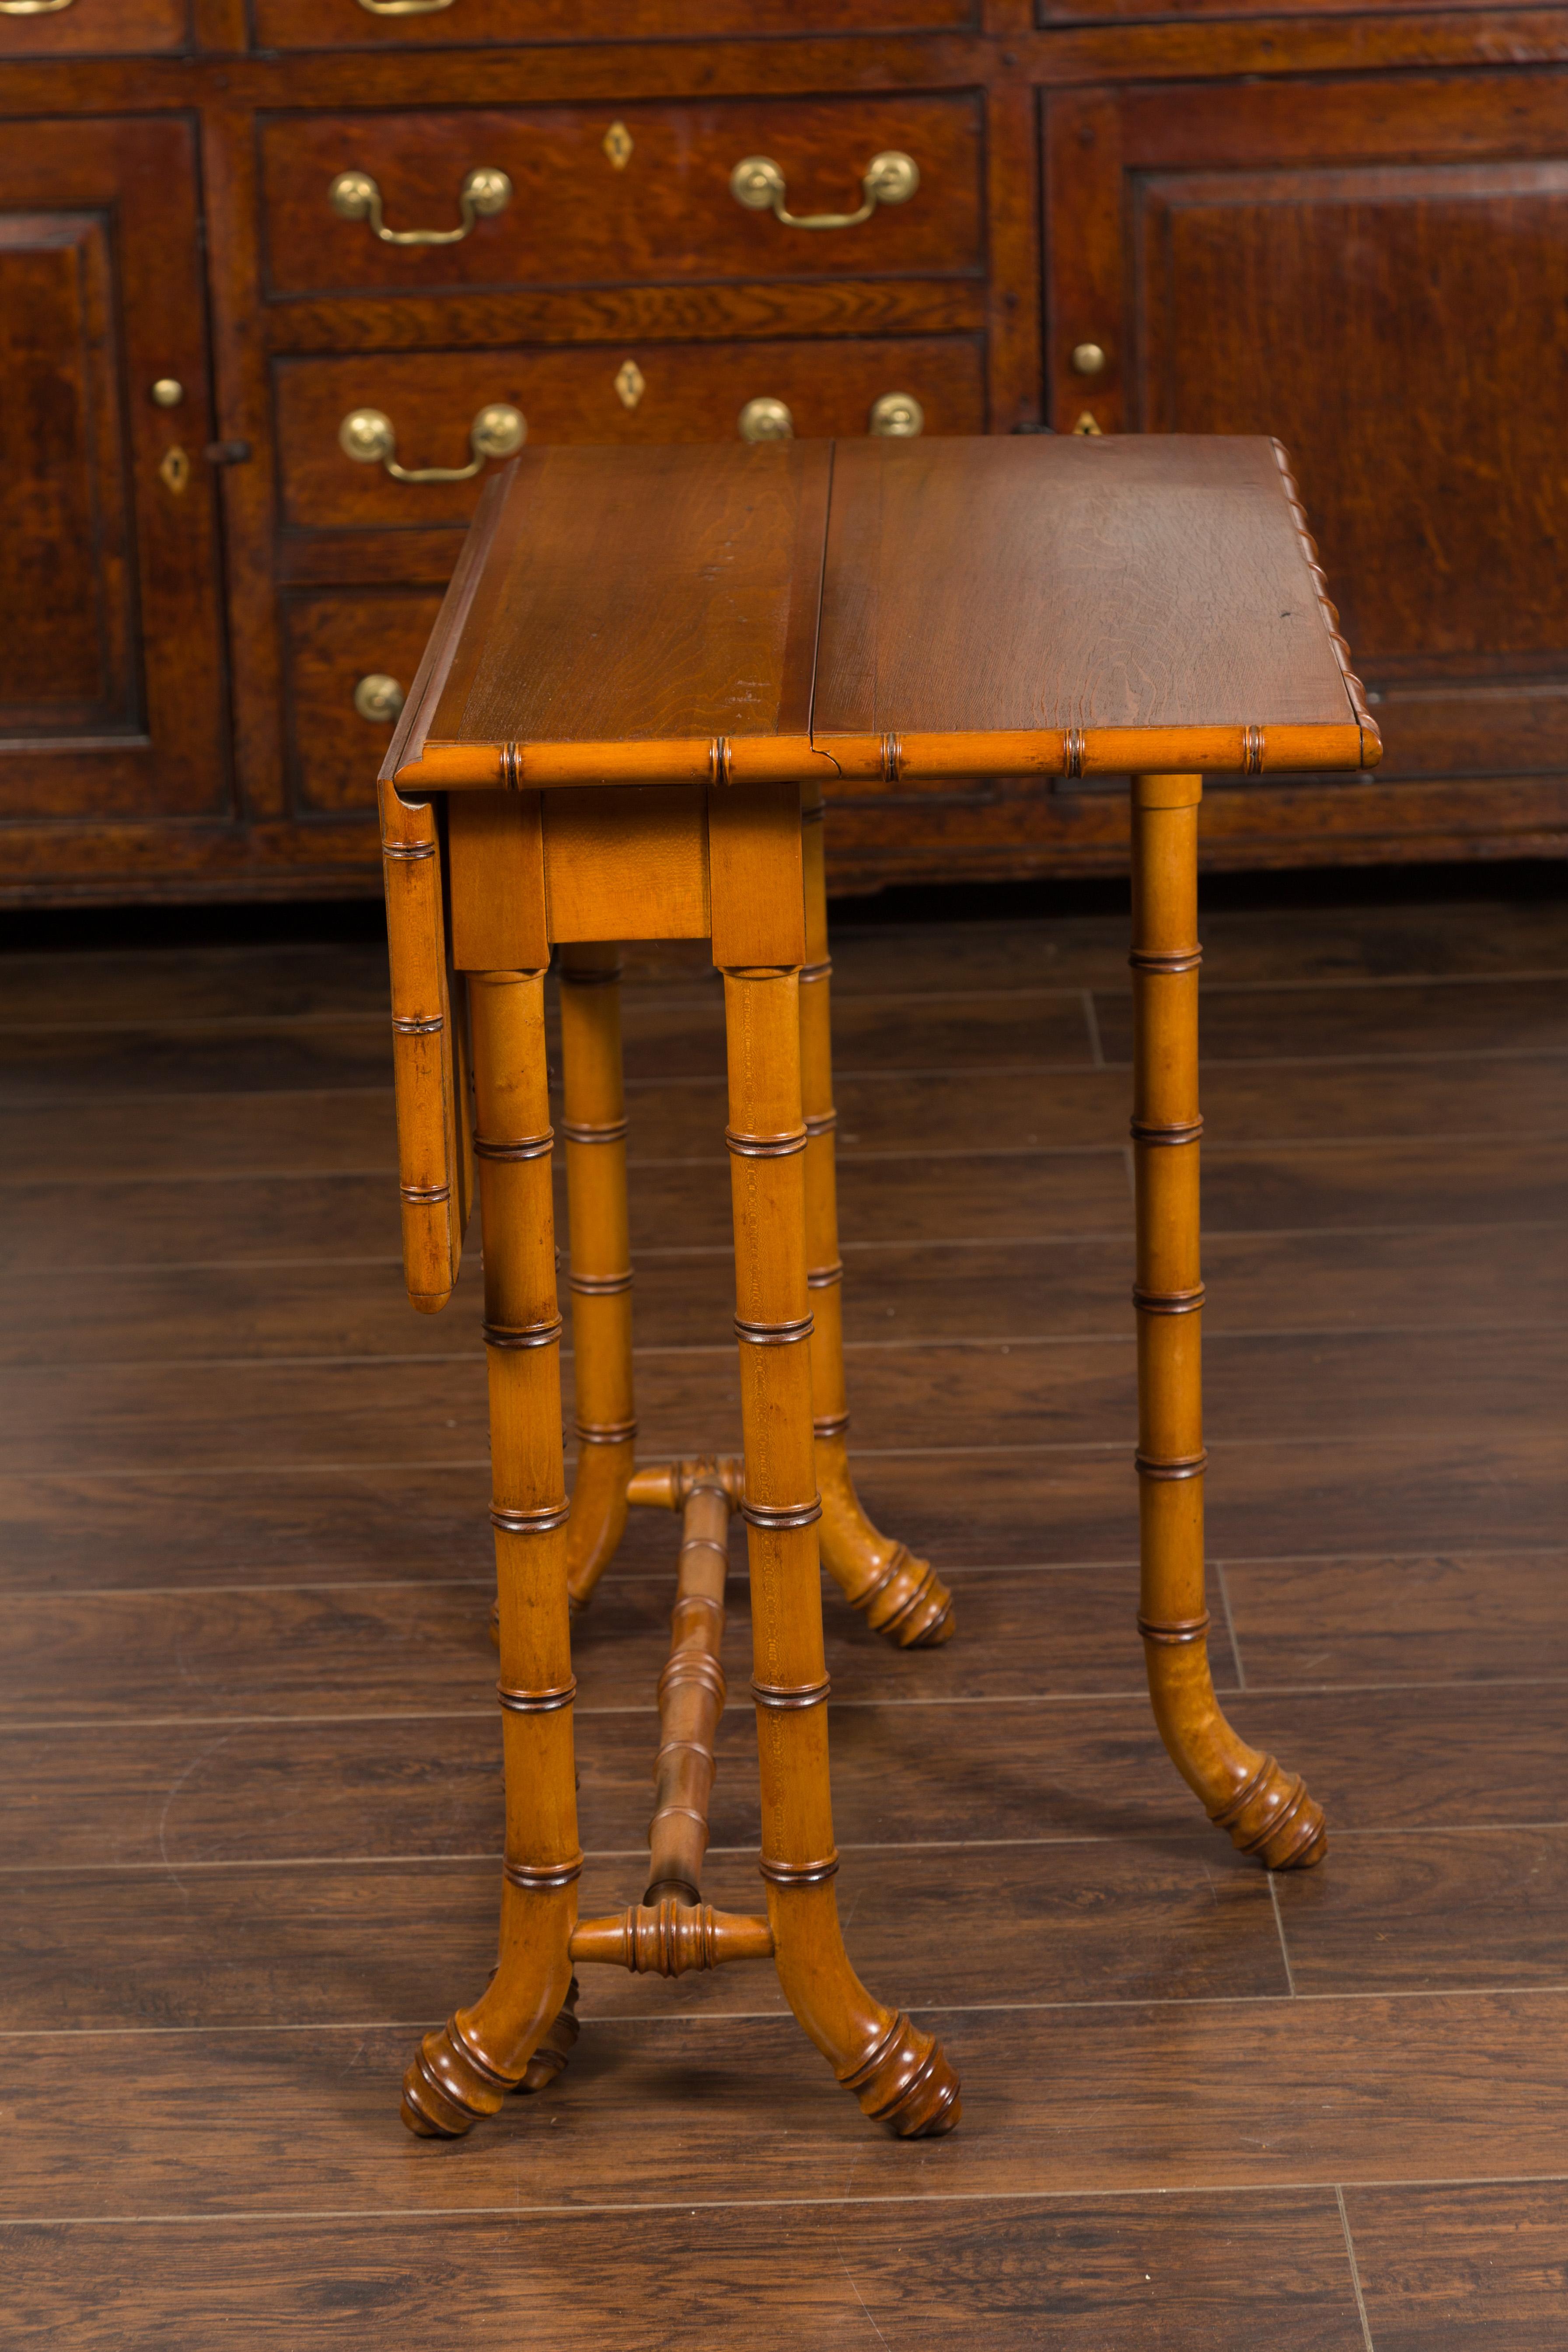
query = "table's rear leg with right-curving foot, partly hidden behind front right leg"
xmin=799 ymin=783 xmax=954 ymax=1649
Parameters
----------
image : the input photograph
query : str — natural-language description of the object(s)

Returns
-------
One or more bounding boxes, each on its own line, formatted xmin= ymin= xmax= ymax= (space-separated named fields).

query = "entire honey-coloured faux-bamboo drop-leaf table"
xmin=381 ymin=440 xmax=1378 ymax=2135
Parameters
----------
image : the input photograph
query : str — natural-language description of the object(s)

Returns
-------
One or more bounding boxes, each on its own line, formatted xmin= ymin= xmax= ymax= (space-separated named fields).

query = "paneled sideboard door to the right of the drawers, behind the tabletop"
xmin=1046 ymin=68 xmax=1568 ymax=809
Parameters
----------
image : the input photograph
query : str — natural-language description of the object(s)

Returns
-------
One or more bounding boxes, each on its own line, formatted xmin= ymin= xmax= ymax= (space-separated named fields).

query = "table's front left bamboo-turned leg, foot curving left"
xmin=402 ymin=972 xmax=583 ymax=2138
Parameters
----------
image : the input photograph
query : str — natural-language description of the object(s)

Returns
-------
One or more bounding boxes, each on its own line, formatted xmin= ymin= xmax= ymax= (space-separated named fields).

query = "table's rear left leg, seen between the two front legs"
xmin=562 ymin=946 xmax=637 ymax=1611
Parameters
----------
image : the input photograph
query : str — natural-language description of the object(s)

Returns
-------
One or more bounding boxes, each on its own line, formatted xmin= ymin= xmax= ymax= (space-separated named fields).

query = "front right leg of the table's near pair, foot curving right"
xmin=724 ymin=969 xmax=959 ymax=2138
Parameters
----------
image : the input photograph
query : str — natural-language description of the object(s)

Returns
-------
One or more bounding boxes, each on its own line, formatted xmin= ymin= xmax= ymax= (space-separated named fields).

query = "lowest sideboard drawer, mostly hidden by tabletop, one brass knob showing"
xmin=282 ymin=588 xmax=442 ymax=816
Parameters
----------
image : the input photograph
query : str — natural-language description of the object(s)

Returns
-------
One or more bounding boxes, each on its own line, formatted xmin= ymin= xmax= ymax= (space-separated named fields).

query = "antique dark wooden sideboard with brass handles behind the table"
xmin=0 ymin=0 xmax=1568 ymax=901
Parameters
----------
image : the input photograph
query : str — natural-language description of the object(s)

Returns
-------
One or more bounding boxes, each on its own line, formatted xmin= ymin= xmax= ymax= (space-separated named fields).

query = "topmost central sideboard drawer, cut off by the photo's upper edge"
xmin=255 ymin=0 xmax=980 ymax=49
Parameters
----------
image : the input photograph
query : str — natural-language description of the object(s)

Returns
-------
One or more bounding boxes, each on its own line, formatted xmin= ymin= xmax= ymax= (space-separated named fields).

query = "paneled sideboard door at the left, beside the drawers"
xmin=0 ymin=118 xmax=230 ymax=851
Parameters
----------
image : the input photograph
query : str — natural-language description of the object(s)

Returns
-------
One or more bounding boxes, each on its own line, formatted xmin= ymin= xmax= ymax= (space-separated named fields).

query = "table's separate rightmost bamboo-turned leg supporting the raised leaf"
xmin=1131 ymin=776 xmax=1328 ymax=1870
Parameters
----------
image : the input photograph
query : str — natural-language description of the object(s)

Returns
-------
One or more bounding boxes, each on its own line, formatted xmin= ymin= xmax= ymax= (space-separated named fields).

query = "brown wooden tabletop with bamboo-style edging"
xmin=383 ymin=435 xmax=1380 ymax=793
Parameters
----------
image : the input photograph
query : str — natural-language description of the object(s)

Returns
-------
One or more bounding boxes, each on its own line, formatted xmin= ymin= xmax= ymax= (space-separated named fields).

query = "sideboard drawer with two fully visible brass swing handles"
xmin=261 ymin=94 xmax=985 ymax=299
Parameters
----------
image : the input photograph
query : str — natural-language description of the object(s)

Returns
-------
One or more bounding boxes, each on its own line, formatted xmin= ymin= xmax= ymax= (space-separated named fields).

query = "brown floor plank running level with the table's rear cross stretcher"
xmin=0 ymin=1428 xmax=1568 ymax=1590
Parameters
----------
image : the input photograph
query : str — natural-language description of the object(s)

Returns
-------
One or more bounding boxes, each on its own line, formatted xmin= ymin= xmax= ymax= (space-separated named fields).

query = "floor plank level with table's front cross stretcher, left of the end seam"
xmin=0 ymin=1832 xmax=1288 ymax=2034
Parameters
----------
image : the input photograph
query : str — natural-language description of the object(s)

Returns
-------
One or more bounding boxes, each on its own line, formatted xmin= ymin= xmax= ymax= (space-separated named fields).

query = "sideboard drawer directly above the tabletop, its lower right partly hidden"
xmin=275 ymin=336 xmax=985 ymax=531
